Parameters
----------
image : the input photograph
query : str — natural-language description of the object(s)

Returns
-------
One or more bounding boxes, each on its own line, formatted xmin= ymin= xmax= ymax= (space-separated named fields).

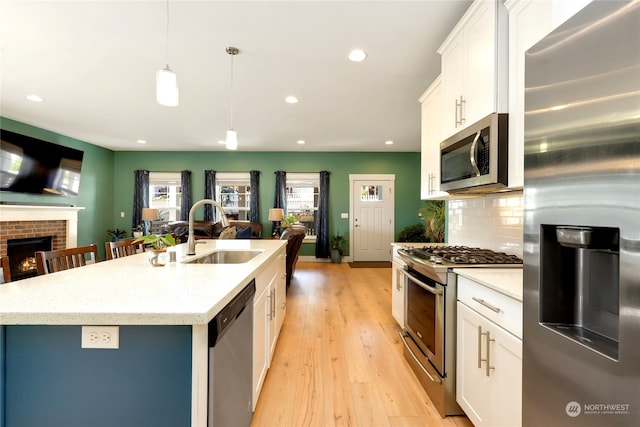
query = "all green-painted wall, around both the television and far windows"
xmin=0 ymin=118 xmax=422 ymax=259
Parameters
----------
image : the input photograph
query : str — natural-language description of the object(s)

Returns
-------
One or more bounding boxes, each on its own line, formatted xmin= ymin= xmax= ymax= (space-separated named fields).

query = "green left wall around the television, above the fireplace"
xmin=0 ymin=117 xmax=114 ymax=259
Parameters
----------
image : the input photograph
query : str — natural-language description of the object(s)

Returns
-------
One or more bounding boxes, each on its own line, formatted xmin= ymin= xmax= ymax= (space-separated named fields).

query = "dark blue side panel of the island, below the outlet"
xmin=0 ymin=325 xmax=192 ymax=427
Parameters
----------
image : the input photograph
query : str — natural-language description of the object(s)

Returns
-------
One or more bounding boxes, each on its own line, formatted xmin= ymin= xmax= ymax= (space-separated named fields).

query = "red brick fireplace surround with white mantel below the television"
xmin=0 ymin=205 xmax=84 ymax=255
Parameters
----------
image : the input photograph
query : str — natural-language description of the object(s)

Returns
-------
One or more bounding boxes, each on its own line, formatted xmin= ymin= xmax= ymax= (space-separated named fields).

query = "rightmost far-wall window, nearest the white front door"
xmin=286 ymin=173 xmax=320 ymax=235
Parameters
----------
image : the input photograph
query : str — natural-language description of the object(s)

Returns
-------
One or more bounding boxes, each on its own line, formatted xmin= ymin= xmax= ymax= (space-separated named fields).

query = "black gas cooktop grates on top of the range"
xmin=406 ymin=246 xmax=522 ymax=265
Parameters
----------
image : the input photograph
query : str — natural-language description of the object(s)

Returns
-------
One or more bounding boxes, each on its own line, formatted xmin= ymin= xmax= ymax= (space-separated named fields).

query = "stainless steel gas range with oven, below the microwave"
xmin=398 ymin=245 xmax=522 ymax=417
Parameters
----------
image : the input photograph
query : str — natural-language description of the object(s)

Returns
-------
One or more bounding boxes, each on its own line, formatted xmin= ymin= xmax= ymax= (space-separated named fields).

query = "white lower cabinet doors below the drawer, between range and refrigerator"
xmin=456 ymin=301 xmax=522 ymax=427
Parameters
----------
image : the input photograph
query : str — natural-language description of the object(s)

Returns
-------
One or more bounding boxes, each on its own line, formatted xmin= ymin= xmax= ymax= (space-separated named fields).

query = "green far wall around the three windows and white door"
xmin=113 ymin=151 xmax=421 ymax=256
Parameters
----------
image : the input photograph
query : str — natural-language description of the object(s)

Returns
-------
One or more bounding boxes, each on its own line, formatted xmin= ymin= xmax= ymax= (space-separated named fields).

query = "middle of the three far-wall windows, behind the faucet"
xmin=216 ymin=172 xmax=251 ymax=221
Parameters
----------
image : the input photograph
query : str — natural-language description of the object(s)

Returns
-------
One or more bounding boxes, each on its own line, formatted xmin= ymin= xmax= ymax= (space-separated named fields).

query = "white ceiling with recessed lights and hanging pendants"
xmin=0 ymin=0 xmax=471 ymax=151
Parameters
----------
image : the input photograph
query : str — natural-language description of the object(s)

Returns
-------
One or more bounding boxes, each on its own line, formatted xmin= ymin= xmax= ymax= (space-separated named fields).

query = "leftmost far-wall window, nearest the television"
xmin=149 ymin=172 xmax=182 ymax=222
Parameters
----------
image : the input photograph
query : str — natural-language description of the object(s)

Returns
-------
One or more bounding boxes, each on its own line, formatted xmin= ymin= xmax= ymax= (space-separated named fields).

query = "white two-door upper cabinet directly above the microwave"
xmin=438 ymin=0 xmax=508 ymax=139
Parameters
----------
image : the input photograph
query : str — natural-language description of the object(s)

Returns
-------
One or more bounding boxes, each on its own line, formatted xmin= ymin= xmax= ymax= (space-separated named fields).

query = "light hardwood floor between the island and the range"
xmin=251 ymin=262 xmax=473 ymax=427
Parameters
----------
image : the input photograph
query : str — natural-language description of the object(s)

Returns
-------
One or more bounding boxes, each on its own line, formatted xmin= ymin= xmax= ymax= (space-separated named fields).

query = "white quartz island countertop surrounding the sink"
xmin=0 ymin=239 xmax=286 ymax=325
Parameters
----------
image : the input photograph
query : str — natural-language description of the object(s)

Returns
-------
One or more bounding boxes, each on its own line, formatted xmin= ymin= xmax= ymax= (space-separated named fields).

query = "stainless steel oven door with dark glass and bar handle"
xmin=401 ymin=270 xmax=446 ymax=376
